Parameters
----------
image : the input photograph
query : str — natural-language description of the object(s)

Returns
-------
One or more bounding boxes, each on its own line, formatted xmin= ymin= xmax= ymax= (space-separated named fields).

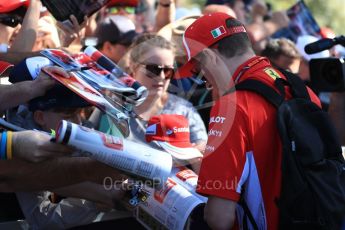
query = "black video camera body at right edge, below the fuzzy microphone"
xmin=309 ymin=58 xmax=345 ymax=92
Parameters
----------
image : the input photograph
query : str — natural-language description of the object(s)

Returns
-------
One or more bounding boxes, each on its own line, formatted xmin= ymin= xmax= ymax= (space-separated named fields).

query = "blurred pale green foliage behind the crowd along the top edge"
xmin=179 ymin=0 xmax=345 ymax=35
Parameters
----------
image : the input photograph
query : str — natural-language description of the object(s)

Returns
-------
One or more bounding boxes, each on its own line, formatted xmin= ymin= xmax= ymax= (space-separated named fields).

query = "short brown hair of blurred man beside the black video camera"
xmin=261 ymin=38 xmax=301 ymax=59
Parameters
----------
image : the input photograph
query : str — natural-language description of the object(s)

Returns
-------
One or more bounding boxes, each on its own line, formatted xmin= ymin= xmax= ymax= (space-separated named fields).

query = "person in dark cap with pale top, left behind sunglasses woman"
xmin=94 ymin=15 xmax=137 ymax=63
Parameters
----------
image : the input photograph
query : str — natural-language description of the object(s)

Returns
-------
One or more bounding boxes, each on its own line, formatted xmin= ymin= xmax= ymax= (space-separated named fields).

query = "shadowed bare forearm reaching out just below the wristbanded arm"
xmin=0 ymin=157 xmax=120 ymax=192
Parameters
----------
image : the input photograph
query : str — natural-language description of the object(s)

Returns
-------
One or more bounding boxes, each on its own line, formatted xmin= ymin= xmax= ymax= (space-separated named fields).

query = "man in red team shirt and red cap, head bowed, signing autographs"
xmin=177 ymin=13 xmax=320 ymax=229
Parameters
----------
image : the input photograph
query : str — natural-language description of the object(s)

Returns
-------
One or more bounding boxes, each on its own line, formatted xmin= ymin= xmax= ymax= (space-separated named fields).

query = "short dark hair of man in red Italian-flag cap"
xmin=217 ymin=18 xmax=254 ymax=58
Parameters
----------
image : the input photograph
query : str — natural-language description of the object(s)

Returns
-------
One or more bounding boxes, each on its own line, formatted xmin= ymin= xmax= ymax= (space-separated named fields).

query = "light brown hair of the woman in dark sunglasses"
xmin=129 ymin=33 xmax=175 ymax=63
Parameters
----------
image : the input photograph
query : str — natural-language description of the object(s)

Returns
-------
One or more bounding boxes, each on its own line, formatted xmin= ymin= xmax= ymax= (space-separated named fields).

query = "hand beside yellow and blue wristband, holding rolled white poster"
xmin=13 ymin=131 xmax=74 ymax=162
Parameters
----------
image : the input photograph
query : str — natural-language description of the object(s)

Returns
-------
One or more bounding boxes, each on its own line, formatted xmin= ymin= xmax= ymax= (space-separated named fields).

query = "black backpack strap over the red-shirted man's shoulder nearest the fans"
xmin=224 ymin=79 xmax=285 ymax=108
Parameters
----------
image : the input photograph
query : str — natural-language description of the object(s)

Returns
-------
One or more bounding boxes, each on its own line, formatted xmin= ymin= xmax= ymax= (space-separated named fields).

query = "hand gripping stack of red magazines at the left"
xmin=32 ymin=66 xmax=70 ymax=97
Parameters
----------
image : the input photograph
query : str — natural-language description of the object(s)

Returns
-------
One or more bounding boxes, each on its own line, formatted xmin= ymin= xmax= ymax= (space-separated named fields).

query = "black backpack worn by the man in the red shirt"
xmin=232 ymin=71 xmax=345 ymax=230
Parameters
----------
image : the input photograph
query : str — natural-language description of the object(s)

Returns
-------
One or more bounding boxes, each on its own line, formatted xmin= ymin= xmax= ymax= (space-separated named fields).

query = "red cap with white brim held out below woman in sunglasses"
xmin=145 ymin=114 xmax=202 ymax=160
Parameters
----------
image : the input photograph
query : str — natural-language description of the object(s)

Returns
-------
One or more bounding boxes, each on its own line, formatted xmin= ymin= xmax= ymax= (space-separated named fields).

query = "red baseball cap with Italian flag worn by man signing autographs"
xmin=175 ymin=12 xmax=247 ymax=79
